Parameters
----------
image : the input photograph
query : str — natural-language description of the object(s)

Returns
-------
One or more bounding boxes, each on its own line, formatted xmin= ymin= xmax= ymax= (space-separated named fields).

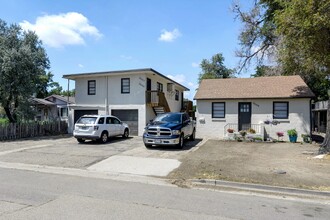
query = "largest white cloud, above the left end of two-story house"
xmin=20 ymin=12 xmax=102 ymax=48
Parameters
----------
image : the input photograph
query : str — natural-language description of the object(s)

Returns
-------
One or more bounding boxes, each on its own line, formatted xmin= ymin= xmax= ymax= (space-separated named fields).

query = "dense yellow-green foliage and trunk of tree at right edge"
xmin=274 ymin=0 xmax=330 ymax=152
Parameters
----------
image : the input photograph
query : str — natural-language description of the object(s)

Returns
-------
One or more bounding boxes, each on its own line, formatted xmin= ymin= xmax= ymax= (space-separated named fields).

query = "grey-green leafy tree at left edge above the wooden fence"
xmin=0 ymin=20 xmax=49 ymax=123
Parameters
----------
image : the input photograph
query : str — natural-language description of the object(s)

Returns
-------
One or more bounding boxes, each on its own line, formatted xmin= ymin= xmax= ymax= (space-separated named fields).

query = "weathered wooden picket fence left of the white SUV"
xmin=0 ymin=121 xmax=68 ymax=141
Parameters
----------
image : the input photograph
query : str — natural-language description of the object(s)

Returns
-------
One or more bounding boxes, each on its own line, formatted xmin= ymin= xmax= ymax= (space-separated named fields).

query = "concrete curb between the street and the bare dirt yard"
xmin=190 ymin=179 xmax=330 ymax=199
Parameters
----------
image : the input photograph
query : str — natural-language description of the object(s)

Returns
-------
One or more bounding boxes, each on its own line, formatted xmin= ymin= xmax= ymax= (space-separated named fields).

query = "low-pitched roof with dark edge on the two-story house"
xmin=63 ymin=68 xmax=189 ymax=91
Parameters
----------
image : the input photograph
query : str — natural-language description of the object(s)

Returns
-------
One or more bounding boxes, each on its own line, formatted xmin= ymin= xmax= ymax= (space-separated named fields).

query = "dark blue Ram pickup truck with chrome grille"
xmin=143 ymin=112 xmax=196 ymax=148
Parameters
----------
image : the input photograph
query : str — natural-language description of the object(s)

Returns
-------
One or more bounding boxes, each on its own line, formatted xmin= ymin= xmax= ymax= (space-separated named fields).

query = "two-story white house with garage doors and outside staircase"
xmin=63 ymin=68 xmax=189 ymax=136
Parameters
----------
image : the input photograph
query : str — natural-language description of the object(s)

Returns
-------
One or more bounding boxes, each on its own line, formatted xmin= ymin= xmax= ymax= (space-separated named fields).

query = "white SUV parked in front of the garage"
xmin=73 ymin=115 xmax=129 ymax=143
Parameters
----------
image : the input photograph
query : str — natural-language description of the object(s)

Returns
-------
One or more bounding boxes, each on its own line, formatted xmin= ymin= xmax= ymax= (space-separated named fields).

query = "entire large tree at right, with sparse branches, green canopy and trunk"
xmin=235 ymin=0 xmax=330 ymax=151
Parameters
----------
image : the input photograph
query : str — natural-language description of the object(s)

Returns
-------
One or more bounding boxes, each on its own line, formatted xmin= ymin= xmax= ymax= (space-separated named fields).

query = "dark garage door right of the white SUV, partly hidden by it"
xmin=111 ymin=109 xmax=139 ymax=135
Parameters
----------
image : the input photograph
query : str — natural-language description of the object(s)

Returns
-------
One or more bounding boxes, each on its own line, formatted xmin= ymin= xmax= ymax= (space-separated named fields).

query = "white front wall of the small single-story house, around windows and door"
xmin=196 ymin=99 xmax=310 ymax=141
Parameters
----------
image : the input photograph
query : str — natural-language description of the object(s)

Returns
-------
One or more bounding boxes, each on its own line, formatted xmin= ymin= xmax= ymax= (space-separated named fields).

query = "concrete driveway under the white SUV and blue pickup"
xmin=0 ymin=136 xmax=199 ymax=176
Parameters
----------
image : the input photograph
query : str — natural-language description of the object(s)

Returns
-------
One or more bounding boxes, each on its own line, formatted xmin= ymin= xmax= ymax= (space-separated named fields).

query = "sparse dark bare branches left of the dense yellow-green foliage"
xmin=233 ymin=0 xmax=282 ymax=73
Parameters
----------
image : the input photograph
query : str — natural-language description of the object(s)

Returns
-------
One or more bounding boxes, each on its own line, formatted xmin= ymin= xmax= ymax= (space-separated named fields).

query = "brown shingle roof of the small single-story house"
xmin=194 ymin=75 xmax=314 ymax=100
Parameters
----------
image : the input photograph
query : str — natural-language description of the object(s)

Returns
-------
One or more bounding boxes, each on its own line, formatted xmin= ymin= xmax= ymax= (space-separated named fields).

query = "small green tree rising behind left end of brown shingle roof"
xmin=198 ymin=53 xmax=234 ymax=83
